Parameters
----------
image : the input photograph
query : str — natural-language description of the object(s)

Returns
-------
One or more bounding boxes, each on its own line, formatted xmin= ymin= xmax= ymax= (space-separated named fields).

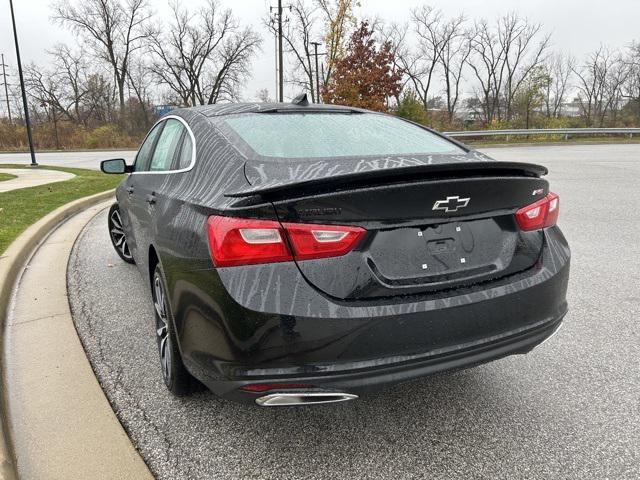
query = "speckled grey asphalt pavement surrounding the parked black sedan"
xmin=68 ymin=145 xmax=640 ymax=479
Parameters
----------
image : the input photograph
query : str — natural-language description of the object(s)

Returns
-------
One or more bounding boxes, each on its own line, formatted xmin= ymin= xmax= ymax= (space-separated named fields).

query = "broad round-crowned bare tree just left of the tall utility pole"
xmin=148 ymin=0 xmax=261 ymax=105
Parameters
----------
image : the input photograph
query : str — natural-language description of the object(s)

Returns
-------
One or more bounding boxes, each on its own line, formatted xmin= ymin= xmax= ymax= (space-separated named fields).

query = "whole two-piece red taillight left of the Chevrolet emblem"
xmin=207 ymin=216 xmax=366 ymax=267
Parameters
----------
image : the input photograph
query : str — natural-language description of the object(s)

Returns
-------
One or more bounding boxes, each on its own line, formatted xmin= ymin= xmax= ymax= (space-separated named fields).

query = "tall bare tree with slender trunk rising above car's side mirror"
xmin=54 ymin=0 xmax=151 ymax=115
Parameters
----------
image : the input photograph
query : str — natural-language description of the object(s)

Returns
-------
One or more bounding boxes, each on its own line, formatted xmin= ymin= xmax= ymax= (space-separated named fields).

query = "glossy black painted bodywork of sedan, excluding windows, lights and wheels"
xmin=106 ymin=104 xmax=570 ymax=401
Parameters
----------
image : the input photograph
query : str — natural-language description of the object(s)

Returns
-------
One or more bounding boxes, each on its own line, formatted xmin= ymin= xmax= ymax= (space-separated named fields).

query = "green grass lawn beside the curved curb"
xmin=0 ymin=164 xmax=124 ymax=253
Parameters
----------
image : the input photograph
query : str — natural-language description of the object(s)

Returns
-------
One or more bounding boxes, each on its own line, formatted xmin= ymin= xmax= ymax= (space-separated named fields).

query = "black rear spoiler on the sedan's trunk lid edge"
xmin=225 ymin=161 xmax=548 ymax=198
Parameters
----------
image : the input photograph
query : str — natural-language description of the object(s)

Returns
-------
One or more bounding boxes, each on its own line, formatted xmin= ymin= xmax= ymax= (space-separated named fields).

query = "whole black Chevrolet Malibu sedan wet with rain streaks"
xmin=102 ymin=101 xmax=570 ymax=406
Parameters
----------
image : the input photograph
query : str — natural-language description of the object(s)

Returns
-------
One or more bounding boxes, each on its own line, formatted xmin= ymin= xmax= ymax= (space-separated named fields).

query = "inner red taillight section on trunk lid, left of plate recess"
xmin=284 ymin=223 xmax=366 ymax=260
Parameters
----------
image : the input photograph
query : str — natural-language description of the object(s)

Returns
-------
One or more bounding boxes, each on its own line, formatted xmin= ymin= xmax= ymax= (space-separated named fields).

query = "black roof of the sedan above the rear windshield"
xmin=170 ymin=102 xmax=368 ymax=117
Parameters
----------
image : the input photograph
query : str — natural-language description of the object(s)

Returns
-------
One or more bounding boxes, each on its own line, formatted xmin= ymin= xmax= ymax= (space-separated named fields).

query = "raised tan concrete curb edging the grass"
xmin=0 ymin=190 xmax=149 ymax=480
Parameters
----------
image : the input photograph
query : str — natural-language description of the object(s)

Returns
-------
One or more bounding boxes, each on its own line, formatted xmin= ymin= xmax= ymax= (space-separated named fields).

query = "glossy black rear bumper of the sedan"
xmin=170 ymin=228 xmax=570 ymax=402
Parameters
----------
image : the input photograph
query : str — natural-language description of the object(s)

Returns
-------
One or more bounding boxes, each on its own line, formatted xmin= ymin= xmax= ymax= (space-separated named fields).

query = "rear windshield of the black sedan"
xmin=225 ymin=113 xmax=463 ymax=158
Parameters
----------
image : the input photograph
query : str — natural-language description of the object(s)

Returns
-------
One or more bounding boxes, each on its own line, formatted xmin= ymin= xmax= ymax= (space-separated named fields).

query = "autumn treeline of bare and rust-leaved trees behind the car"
xmin=0 ymin=0 xmax=640 ymax=150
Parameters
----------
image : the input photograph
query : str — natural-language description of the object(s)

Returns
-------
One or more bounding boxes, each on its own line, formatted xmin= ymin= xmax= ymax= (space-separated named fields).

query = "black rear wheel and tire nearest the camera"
xmin=151 ymin=264 xmax=199 ymax=396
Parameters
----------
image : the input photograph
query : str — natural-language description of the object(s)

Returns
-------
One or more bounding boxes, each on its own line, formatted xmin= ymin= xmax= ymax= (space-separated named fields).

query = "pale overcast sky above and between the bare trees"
xmin=0 ymin=0 xmax=640 ymax=99
